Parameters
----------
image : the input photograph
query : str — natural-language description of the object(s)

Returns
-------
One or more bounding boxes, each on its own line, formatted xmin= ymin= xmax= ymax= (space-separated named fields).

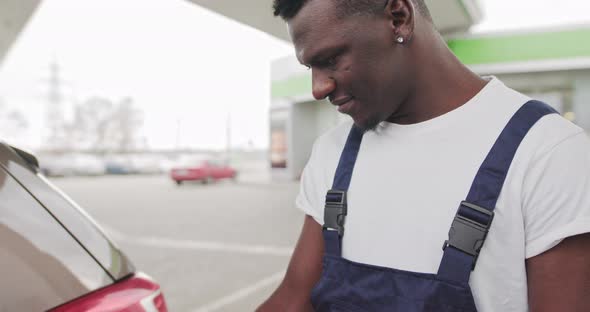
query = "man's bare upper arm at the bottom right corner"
xmin=526 ymin=233 xmax=590 ymax=312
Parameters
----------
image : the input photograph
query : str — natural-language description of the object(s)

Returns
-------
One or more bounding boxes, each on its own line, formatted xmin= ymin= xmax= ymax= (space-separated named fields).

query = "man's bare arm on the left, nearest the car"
xmin=256 ymin=216 xmax=324 ymax=312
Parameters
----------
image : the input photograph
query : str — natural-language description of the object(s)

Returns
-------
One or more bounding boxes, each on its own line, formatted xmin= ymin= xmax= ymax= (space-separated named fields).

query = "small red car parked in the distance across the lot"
xmin=170 ymin=159 xmax=237 ymax=185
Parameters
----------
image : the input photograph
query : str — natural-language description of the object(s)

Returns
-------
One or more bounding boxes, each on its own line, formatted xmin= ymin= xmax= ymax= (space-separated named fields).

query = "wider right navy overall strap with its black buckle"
xmin=437 ymin=101 xmax=556 ymax=284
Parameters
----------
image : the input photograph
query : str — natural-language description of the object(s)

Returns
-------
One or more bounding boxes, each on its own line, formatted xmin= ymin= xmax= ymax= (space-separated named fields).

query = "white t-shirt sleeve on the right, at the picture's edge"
xmin=522 ymin=131 xmax=590 ymax=259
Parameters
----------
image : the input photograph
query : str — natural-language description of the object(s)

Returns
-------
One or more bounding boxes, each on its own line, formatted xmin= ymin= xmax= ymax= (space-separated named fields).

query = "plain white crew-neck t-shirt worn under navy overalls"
xmin=296 ymin=78 xmax=590 ymax=312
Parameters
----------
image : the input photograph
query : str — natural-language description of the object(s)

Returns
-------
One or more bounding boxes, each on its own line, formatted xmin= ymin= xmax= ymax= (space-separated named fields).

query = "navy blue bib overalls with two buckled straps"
xmin=311 ymin=101 xmax=555 ymax=312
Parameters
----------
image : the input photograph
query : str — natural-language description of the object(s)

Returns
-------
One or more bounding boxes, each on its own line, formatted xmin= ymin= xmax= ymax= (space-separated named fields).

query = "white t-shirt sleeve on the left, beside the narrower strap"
xmin=295 ymin=142 xmax=325 ymax=224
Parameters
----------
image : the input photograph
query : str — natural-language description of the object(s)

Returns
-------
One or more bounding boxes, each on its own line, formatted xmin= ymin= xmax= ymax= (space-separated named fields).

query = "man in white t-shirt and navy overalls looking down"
xmin=258 ymin=0 xmax=590 ymax=312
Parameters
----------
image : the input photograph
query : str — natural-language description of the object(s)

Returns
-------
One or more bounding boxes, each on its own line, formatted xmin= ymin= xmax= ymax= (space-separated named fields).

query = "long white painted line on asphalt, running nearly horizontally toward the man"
xmin=103 ymin=226 xmax=293 ymax=257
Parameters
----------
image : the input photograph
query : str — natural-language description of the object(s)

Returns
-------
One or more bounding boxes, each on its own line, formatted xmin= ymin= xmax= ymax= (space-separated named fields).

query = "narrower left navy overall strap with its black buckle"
xmin=323 ymin=125 xmax=363 ymax=256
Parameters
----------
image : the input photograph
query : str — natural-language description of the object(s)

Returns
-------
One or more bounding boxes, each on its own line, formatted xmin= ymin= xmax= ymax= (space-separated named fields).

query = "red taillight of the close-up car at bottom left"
xmin=49 ymin=273 xmax=168 ymax=312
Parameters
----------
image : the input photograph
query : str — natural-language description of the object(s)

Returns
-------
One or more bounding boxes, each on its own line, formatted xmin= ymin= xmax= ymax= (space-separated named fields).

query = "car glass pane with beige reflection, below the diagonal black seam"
xmin=0 ymin=168 xmax=112 ymax=311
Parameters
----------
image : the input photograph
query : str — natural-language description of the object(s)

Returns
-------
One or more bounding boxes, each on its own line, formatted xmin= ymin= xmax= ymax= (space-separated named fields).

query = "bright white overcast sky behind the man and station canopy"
xmin=0 ymin=0 xmax=590 ymax=149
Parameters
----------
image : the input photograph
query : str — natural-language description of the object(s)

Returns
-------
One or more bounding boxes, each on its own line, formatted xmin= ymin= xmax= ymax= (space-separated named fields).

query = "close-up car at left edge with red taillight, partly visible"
xmin=0 ymin=142 xmax=167 ymax=312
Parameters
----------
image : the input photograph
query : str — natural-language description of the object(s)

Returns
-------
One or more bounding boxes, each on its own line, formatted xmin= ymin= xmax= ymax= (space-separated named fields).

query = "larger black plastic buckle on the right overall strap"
xmin=443 ymin=201 xmax=494 ymax=270
